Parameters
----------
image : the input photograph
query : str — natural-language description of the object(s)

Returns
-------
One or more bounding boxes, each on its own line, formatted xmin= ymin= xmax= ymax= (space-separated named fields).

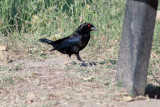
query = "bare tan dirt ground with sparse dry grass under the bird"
xmin=0 ymin=51 xmax=160 ymax=107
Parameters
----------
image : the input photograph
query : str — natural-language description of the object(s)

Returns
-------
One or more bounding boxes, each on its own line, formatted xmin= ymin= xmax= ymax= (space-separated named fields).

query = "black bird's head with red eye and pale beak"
xmin=78 ymin=23 xmax=97 ymax=33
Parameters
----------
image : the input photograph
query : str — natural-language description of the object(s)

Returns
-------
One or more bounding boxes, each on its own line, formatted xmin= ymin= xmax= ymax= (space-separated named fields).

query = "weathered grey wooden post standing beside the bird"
xmin=116 ymin=0 xmax=158 ymax=96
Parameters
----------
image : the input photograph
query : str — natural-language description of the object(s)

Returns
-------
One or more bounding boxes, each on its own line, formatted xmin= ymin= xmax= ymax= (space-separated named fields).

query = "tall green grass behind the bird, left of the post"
xmin=0 ymin=0 xmax=125 ymax=56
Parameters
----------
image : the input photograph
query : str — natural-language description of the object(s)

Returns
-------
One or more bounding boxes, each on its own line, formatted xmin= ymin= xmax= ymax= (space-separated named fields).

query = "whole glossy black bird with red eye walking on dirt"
xmin=39 ymin=23 xmax=96 ymax=61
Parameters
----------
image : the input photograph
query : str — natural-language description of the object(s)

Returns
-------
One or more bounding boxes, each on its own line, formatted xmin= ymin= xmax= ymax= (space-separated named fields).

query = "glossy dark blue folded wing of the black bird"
xmin=54 ymin=36 xmax=81 ymax=50
